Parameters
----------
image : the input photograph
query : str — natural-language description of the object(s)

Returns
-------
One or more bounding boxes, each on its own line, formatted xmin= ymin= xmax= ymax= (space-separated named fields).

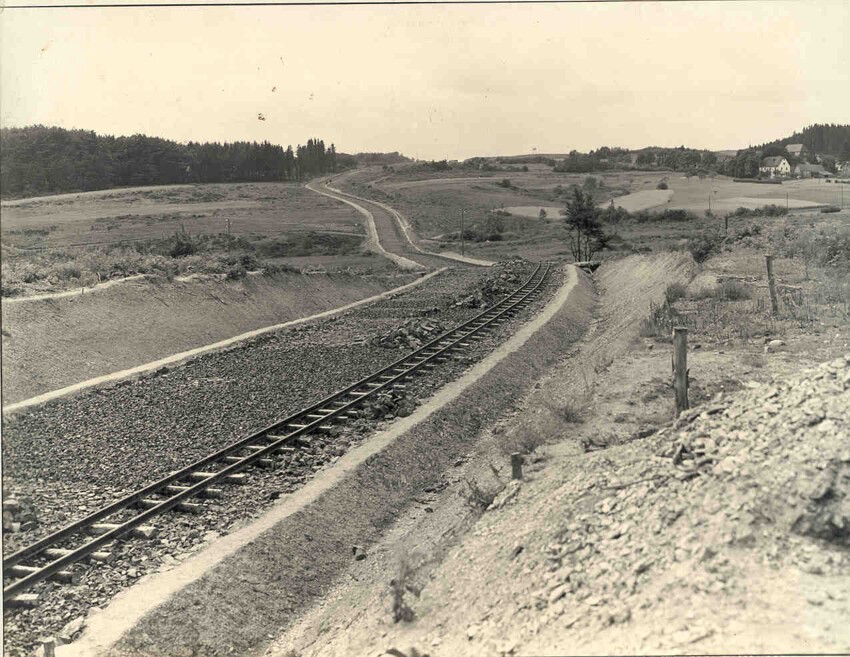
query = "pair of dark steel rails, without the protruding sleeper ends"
xmin=3 ymin=264 xmax=550 ymax=600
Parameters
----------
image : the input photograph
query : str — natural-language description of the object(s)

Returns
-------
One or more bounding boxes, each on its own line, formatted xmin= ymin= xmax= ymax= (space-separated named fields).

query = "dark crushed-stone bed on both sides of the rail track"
xmin=3 ymin=263 xmax=546 ymax=655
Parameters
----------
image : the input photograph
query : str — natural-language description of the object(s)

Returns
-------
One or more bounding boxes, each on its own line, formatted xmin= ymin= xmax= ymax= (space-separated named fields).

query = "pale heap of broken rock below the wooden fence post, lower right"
xmin=517 ymin=355 xmax=850 ymax=647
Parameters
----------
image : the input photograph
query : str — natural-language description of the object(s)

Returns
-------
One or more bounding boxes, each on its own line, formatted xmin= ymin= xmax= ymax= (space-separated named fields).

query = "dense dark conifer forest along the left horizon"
xmin=0 ymin=125 xmax=344 ymax=198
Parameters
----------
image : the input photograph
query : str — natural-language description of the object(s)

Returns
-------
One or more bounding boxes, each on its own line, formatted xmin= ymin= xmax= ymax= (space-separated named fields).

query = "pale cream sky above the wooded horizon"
xmin=0 ymin=0 xmax=850 ymax=159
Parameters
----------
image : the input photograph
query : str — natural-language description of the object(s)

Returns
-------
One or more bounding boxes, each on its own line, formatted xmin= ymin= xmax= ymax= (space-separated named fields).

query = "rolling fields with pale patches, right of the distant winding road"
xmin=338 ymin=165 xmax=850 ymax=260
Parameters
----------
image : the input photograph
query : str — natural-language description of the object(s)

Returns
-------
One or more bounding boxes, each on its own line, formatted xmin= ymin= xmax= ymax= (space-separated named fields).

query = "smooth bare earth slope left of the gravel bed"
xmin=3 ymin=273 xmax=416 ymax=404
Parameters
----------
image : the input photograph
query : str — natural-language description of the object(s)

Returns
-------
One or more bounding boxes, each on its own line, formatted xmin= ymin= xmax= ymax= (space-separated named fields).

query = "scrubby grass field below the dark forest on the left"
xmin=0 ymin=178 xmax=391 ymax=296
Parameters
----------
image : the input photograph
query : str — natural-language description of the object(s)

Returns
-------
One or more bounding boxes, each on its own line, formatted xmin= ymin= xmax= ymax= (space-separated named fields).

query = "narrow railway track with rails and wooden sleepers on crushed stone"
xmin=3 ymin=264 xmax=551 ymax=606
